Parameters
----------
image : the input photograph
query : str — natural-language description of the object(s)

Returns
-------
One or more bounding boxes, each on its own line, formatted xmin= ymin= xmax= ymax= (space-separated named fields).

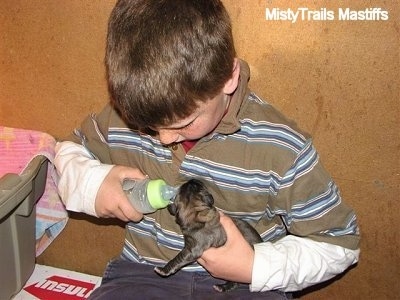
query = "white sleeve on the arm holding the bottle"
xmin=54 ymin=141 xmax=113 ymax=216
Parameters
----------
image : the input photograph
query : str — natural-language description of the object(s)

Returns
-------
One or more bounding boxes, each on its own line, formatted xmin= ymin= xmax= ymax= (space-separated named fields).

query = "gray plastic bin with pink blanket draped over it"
xmin=0 ymin=156 xmax=47 ymax=300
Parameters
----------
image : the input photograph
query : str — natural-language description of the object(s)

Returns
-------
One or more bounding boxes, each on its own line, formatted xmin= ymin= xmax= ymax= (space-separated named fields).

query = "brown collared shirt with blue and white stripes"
xmin=70 ymin=59 xmax=359 ymax=271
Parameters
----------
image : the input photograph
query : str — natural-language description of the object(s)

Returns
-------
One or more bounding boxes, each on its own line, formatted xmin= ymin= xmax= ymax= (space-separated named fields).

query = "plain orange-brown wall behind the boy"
xmin=0 ymin=0 xmax=400 ymax=299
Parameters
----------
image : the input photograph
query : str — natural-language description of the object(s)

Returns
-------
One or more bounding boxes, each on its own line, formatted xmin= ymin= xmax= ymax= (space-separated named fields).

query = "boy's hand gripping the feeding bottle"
xmin=95 ymin=166 xmax=146 ymax=222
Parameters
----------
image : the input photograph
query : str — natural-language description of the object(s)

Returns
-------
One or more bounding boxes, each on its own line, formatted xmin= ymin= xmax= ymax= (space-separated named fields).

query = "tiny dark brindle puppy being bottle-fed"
xmin=154 ymin=179 xmax=262 ymax=292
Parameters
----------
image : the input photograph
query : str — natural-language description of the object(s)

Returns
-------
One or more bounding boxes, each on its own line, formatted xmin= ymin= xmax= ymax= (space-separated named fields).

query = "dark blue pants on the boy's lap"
xmin=89 ymin=259 xmax=291 ymax=300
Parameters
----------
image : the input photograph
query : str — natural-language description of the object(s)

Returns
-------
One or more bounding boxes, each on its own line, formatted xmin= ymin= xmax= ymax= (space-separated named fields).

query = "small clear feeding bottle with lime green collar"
xmin=122 ymin=178 xmax=178 ymax=214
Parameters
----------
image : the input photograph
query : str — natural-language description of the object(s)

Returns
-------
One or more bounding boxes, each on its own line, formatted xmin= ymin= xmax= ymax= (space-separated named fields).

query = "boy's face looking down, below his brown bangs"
xmin=151 ymin=92 xmax=230 ymax=145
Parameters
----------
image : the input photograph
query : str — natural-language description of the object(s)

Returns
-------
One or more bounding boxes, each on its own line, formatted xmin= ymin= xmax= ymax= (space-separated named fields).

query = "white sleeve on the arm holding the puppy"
xmin=250 ymin=235 xmax=360 ymax=292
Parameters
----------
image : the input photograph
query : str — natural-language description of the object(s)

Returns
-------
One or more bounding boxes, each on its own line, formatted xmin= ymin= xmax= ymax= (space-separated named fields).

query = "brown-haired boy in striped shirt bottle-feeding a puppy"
xmin=55 ymin=0 xmax=359 ymax=299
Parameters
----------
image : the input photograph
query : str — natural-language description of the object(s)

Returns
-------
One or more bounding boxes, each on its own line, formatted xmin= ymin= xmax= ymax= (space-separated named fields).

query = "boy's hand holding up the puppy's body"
xmin=197 ymin=213 xmax=254 ymax=283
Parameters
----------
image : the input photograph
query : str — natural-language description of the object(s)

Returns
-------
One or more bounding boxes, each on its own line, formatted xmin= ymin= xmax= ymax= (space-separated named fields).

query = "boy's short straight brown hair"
xmin=106 ymin=0 xmax=235 ymax=134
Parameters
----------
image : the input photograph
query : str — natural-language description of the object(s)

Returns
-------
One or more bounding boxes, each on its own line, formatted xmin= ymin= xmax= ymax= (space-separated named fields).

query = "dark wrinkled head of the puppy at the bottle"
xmin=168 ymin=179 xmax=219 ymax=228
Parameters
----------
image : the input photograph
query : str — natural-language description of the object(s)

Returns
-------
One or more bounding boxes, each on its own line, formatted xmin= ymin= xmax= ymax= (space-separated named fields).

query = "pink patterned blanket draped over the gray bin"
xmin=0 ymin=126 xmax=68 ymax=256
